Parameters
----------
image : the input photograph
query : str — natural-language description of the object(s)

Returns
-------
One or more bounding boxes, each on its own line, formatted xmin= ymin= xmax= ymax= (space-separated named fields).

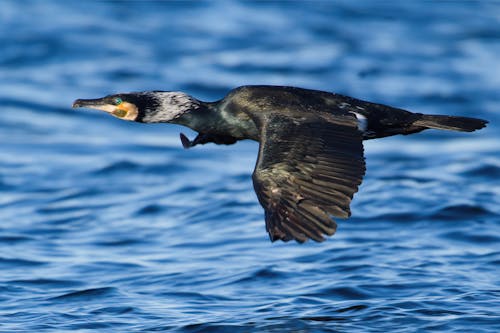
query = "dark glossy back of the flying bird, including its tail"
xmin=222 ymin=85 xmax=486 ymax=140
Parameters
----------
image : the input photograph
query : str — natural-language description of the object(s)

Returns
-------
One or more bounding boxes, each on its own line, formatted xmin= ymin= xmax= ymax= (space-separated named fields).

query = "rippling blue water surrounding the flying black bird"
xmin=0 ymin=0 xmax=500 ymax=332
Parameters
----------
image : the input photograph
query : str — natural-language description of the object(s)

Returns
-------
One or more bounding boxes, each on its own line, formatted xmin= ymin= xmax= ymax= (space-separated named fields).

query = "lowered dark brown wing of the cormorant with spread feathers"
xmin=252 ymin=115 xmax=365 ymax=243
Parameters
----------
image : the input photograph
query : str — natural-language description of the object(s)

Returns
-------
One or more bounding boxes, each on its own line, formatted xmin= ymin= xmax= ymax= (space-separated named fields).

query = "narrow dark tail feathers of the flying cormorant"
xmin=412 ymin=114 xmax=488 ymax=132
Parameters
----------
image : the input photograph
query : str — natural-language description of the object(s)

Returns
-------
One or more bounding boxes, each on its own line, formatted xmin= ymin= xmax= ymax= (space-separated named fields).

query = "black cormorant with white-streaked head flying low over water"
xmin=73 ymin=86 xmax=487 ymax=242
